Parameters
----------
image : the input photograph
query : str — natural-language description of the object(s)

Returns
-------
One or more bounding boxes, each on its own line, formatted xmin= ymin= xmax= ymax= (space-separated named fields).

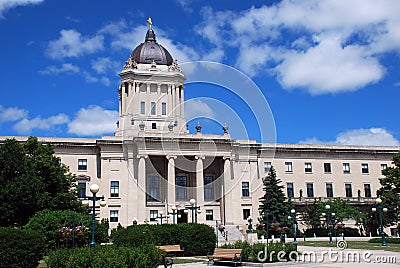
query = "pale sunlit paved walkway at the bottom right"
xmin=159 ymin=246 xmax=400 ymax=268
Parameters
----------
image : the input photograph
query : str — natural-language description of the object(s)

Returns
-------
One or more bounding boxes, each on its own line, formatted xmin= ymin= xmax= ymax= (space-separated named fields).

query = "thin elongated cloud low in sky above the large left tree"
xmin=13 ymin=113 xmax=69 ymax=135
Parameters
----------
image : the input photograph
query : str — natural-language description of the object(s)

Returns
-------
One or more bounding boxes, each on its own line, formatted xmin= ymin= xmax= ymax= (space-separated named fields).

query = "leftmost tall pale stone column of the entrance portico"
xmin=137 ymin=155 xmax=148 ymax=223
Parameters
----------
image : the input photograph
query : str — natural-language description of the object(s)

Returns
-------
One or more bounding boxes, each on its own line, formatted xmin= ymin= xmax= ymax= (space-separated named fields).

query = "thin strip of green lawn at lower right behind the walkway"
xmin=298 ymin=241 xmax=400 ymax=252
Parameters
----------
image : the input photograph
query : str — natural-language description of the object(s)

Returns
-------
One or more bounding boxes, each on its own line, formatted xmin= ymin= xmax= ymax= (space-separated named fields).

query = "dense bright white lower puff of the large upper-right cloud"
xmin=276 ymin=34 xmax=385 ymax=94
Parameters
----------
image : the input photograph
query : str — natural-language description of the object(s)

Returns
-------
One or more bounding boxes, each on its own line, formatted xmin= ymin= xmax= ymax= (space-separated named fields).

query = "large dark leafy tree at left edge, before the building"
xmin=0 ymin=137 xmax=82 ymax=226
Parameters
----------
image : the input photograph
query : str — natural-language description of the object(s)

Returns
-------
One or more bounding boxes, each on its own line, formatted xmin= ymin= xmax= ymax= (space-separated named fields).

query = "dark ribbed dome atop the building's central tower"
xmin=131 ymin=28 xmax=173 ymax=65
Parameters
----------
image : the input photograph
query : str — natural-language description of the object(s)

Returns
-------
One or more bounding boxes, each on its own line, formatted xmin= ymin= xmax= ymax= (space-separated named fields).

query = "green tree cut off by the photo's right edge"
xmin=376 ymin=153 xmax=400 ymax=226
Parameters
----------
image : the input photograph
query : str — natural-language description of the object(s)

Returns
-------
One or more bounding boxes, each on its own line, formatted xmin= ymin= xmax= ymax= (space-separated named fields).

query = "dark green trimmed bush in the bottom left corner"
xmin=0 ymin=228 xmax=45 ymax=268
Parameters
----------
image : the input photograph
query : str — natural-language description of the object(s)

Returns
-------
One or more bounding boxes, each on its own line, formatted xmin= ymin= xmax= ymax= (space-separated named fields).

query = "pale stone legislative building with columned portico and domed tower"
xmin=0 ymin=27 xmax=399 ymax=234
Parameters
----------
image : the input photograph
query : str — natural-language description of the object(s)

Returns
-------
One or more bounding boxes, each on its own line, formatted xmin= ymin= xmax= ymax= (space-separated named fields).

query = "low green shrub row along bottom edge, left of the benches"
xmin=45 ymin=245 xmax=162 ymax=268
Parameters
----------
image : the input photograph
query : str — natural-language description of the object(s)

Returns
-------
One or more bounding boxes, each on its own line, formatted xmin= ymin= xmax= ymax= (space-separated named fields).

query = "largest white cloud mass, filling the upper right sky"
xmin=196 ymin=0 xmax=400 ymax=94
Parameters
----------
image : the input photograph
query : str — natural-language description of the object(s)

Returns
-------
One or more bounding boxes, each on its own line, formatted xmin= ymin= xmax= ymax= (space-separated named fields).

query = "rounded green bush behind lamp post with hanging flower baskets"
xmin=24 ymin=209 xmax=108 ymax=249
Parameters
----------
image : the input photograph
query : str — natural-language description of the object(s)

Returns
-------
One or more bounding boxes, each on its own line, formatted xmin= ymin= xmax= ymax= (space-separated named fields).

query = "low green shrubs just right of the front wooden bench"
xmin=221 ymin=241 xmax=297 ymax=262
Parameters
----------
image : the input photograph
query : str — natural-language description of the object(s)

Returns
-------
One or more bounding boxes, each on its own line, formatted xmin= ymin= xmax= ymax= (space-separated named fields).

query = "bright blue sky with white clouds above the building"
xmin=0 ymin=0 xmax=400 ymax=146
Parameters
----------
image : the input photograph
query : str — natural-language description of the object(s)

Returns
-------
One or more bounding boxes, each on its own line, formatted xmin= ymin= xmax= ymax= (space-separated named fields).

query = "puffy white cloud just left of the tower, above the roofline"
xmin=68 ymin=105 xmax=118 ymax=136
